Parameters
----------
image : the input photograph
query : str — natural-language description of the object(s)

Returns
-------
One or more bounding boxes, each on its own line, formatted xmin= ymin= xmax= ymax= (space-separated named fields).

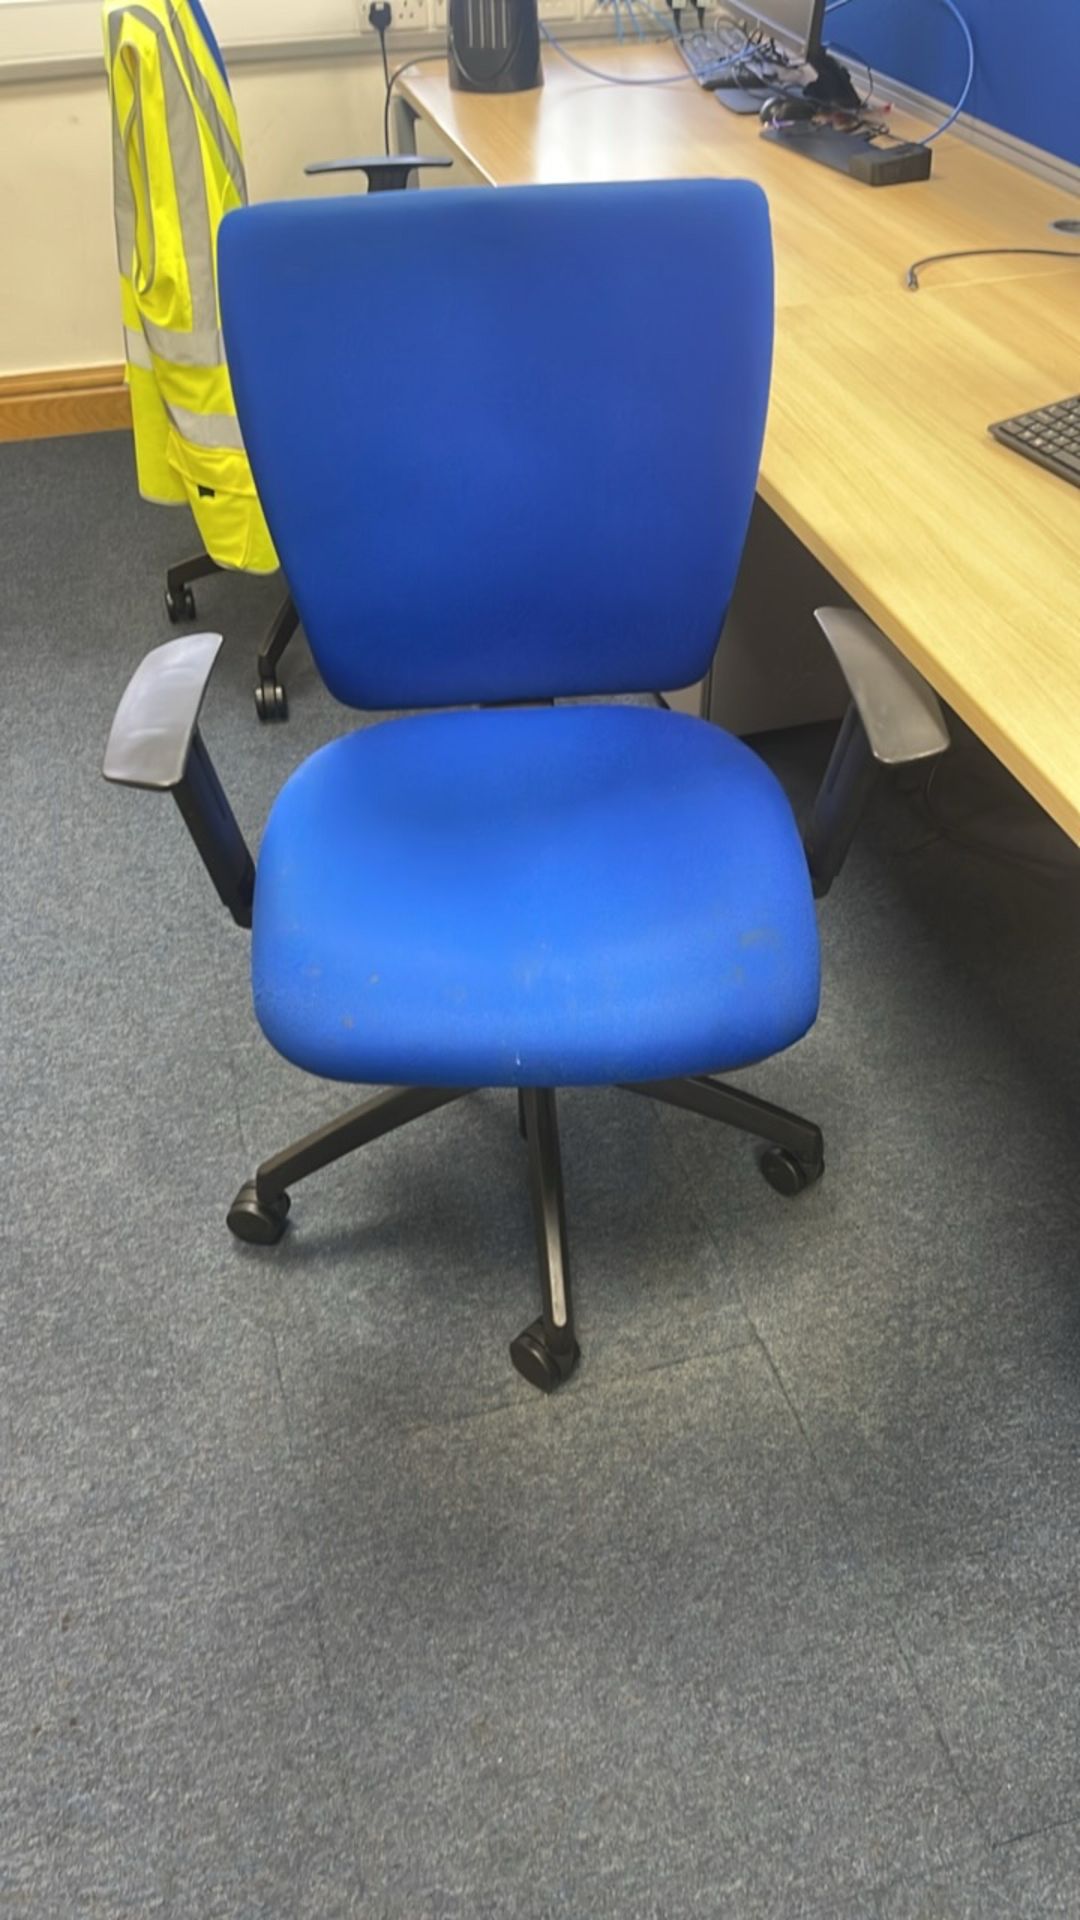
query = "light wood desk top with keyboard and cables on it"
xmin=404 ymin=42 xmax=1080 ymax=841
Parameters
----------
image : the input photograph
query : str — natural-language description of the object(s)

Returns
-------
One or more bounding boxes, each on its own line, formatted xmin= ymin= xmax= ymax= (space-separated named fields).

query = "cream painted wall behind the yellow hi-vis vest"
xmin=0 ymin=58 xmax=463 ymax=376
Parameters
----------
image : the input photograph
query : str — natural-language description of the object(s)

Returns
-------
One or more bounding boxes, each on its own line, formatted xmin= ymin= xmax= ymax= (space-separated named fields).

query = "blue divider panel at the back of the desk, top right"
xmin=824 ymin=0 xmax=1080 ymax=165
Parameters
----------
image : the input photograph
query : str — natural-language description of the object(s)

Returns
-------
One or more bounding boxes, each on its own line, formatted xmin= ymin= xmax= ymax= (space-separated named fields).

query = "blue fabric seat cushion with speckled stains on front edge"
xmin=252 ymin=705 xmax=819 ymax=1087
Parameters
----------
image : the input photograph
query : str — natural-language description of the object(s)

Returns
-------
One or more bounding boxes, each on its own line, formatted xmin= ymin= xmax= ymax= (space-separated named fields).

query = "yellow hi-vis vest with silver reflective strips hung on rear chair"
xmin=104 ymin=0 xmax=277 ymax=572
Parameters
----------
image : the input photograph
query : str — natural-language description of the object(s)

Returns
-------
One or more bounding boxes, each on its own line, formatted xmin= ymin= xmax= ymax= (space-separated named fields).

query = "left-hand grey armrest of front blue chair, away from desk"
xmin=102 ymin=634 xmax=256 ymax=927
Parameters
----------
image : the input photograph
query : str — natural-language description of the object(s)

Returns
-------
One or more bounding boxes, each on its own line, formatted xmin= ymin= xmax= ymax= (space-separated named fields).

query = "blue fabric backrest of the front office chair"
xmin=219 ymin=180 xmax=773 ymax=708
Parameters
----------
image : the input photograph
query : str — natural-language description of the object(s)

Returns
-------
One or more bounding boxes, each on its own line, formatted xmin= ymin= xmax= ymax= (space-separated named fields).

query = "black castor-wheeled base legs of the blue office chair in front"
xmin=227 ymin=1075 xmax=824 ymax=1394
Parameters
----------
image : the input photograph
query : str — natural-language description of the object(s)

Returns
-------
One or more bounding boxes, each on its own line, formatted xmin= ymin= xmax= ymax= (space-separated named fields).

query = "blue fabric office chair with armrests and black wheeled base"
xmin=106 ymin=180 xmax=940 ymax=1390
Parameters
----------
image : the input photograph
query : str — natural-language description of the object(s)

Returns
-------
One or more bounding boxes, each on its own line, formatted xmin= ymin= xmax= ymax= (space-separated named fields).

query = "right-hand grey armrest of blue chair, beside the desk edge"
xmin=803 ymin=607 xmax=949 ymax=899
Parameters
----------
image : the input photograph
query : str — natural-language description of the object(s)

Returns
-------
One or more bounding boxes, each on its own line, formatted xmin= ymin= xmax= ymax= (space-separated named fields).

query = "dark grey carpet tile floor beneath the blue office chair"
xmin=0 ymin=436 xmax=1080 ymax=1920
